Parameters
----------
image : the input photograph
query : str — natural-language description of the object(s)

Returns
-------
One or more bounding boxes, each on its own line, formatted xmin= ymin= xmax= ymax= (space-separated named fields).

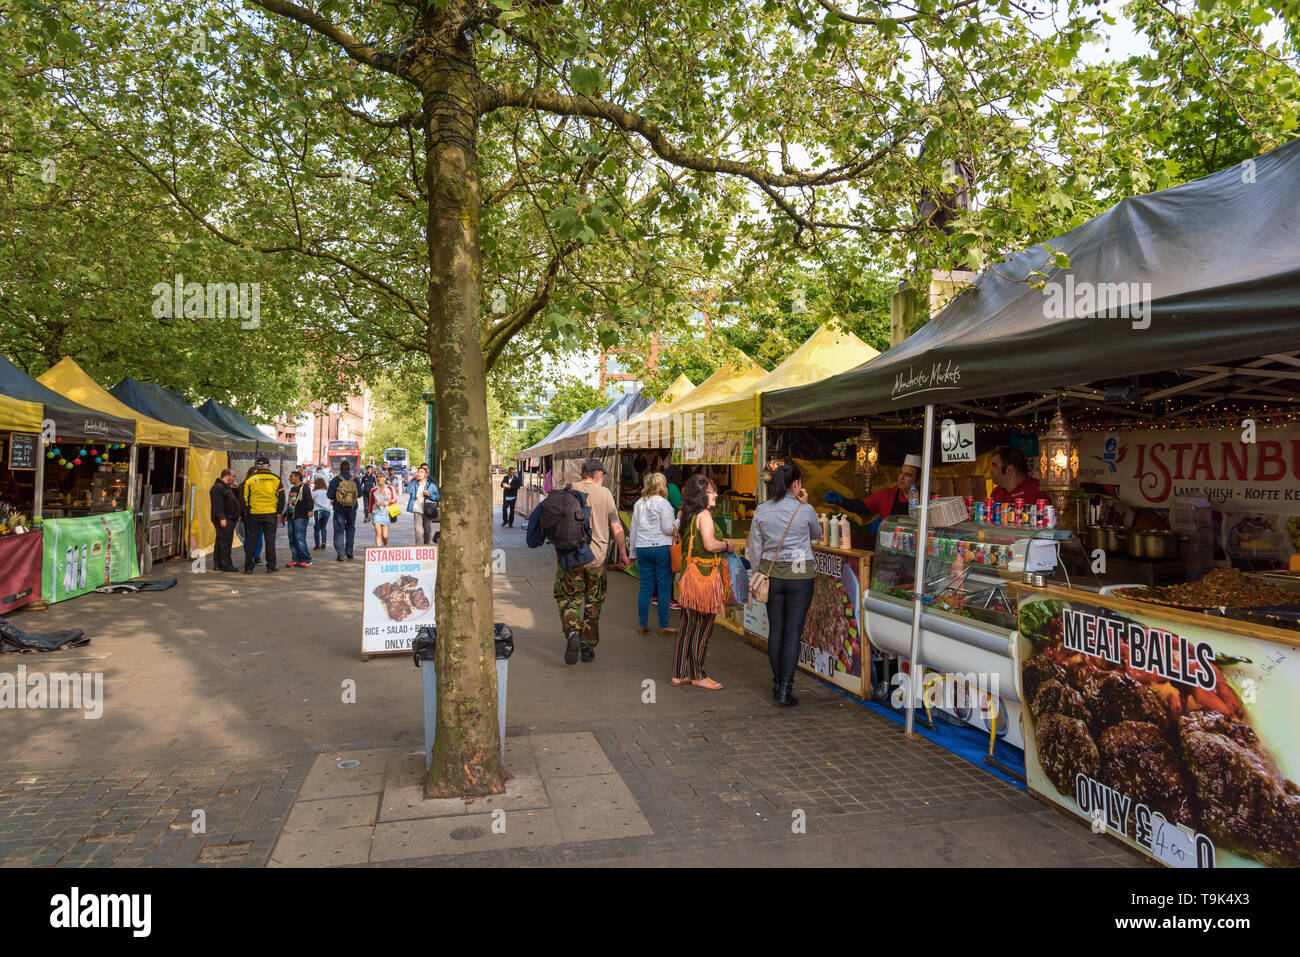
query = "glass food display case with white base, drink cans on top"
xmin=865 ymin=516 xmax=1100 ymax=748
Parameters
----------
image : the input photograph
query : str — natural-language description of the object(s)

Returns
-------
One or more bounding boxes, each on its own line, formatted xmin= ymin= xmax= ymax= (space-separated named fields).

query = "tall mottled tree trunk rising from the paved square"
xmin=419 ymin=26 xmax=506 ymax=797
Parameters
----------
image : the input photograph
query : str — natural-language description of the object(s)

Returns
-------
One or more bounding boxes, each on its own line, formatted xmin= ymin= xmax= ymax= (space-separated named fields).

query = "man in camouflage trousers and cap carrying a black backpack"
xmin=528 ymin=459 xmax=631 ymax=664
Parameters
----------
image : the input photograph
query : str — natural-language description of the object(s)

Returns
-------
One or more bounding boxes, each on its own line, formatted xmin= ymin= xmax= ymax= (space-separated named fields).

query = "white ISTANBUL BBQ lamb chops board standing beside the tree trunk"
xmin=361 ymin=545 xmax=438 ymax=655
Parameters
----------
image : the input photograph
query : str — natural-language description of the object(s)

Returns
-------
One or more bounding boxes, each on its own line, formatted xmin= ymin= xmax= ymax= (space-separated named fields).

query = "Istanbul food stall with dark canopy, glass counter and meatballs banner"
xmin=764 ymin=142 xmax=1300 ymax=866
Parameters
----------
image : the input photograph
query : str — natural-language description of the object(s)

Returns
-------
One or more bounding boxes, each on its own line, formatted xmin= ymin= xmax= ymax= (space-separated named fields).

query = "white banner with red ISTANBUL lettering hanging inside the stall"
xmin=1079 ymin=425 xmax=1300 ymax=515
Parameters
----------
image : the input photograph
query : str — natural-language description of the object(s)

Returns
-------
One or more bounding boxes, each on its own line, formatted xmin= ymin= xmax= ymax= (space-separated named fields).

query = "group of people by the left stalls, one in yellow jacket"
xmin=208 ymin=455 xmax=439 ymax=566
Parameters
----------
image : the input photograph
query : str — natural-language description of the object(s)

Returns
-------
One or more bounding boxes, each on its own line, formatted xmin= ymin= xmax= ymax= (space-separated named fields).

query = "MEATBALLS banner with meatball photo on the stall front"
xmin=1019 ymin=594 xmax=1300 ymax=867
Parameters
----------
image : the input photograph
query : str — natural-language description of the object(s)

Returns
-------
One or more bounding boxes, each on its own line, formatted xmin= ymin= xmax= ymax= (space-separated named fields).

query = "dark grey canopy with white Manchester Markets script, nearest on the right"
xmin=763 ymin=140 xmax=1300 ymax=424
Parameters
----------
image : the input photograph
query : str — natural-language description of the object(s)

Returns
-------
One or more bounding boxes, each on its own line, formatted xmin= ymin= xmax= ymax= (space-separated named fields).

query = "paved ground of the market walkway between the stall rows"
xmin=0 ymin=516 xmax=1141 ymax=867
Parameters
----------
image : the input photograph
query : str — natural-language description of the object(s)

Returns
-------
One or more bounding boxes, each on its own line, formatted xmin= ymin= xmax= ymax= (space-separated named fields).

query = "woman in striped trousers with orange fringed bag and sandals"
xmin=659 ymin=475 xmax=732 ymax=692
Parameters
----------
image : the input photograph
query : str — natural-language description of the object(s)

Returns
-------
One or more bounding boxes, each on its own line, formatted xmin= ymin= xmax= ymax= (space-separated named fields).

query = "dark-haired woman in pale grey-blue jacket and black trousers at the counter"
xmin=745 ymin=463 xmax=822 ymax=705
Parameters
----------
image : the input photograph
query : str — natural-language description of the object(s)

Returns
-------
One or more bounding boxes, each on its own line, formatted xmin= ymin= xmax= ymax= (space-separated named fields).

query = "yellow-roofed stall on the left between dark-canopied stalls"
xmin=36 ymin=356 xmax=190 ymax=560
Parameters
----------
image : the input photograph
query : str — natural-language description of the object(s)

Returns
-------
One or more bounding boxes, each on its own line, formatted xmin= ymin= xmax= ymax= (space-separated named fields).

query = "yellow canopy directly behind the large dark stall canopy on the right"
xmin=673 ymin=320 xmax=880 ymax=465
